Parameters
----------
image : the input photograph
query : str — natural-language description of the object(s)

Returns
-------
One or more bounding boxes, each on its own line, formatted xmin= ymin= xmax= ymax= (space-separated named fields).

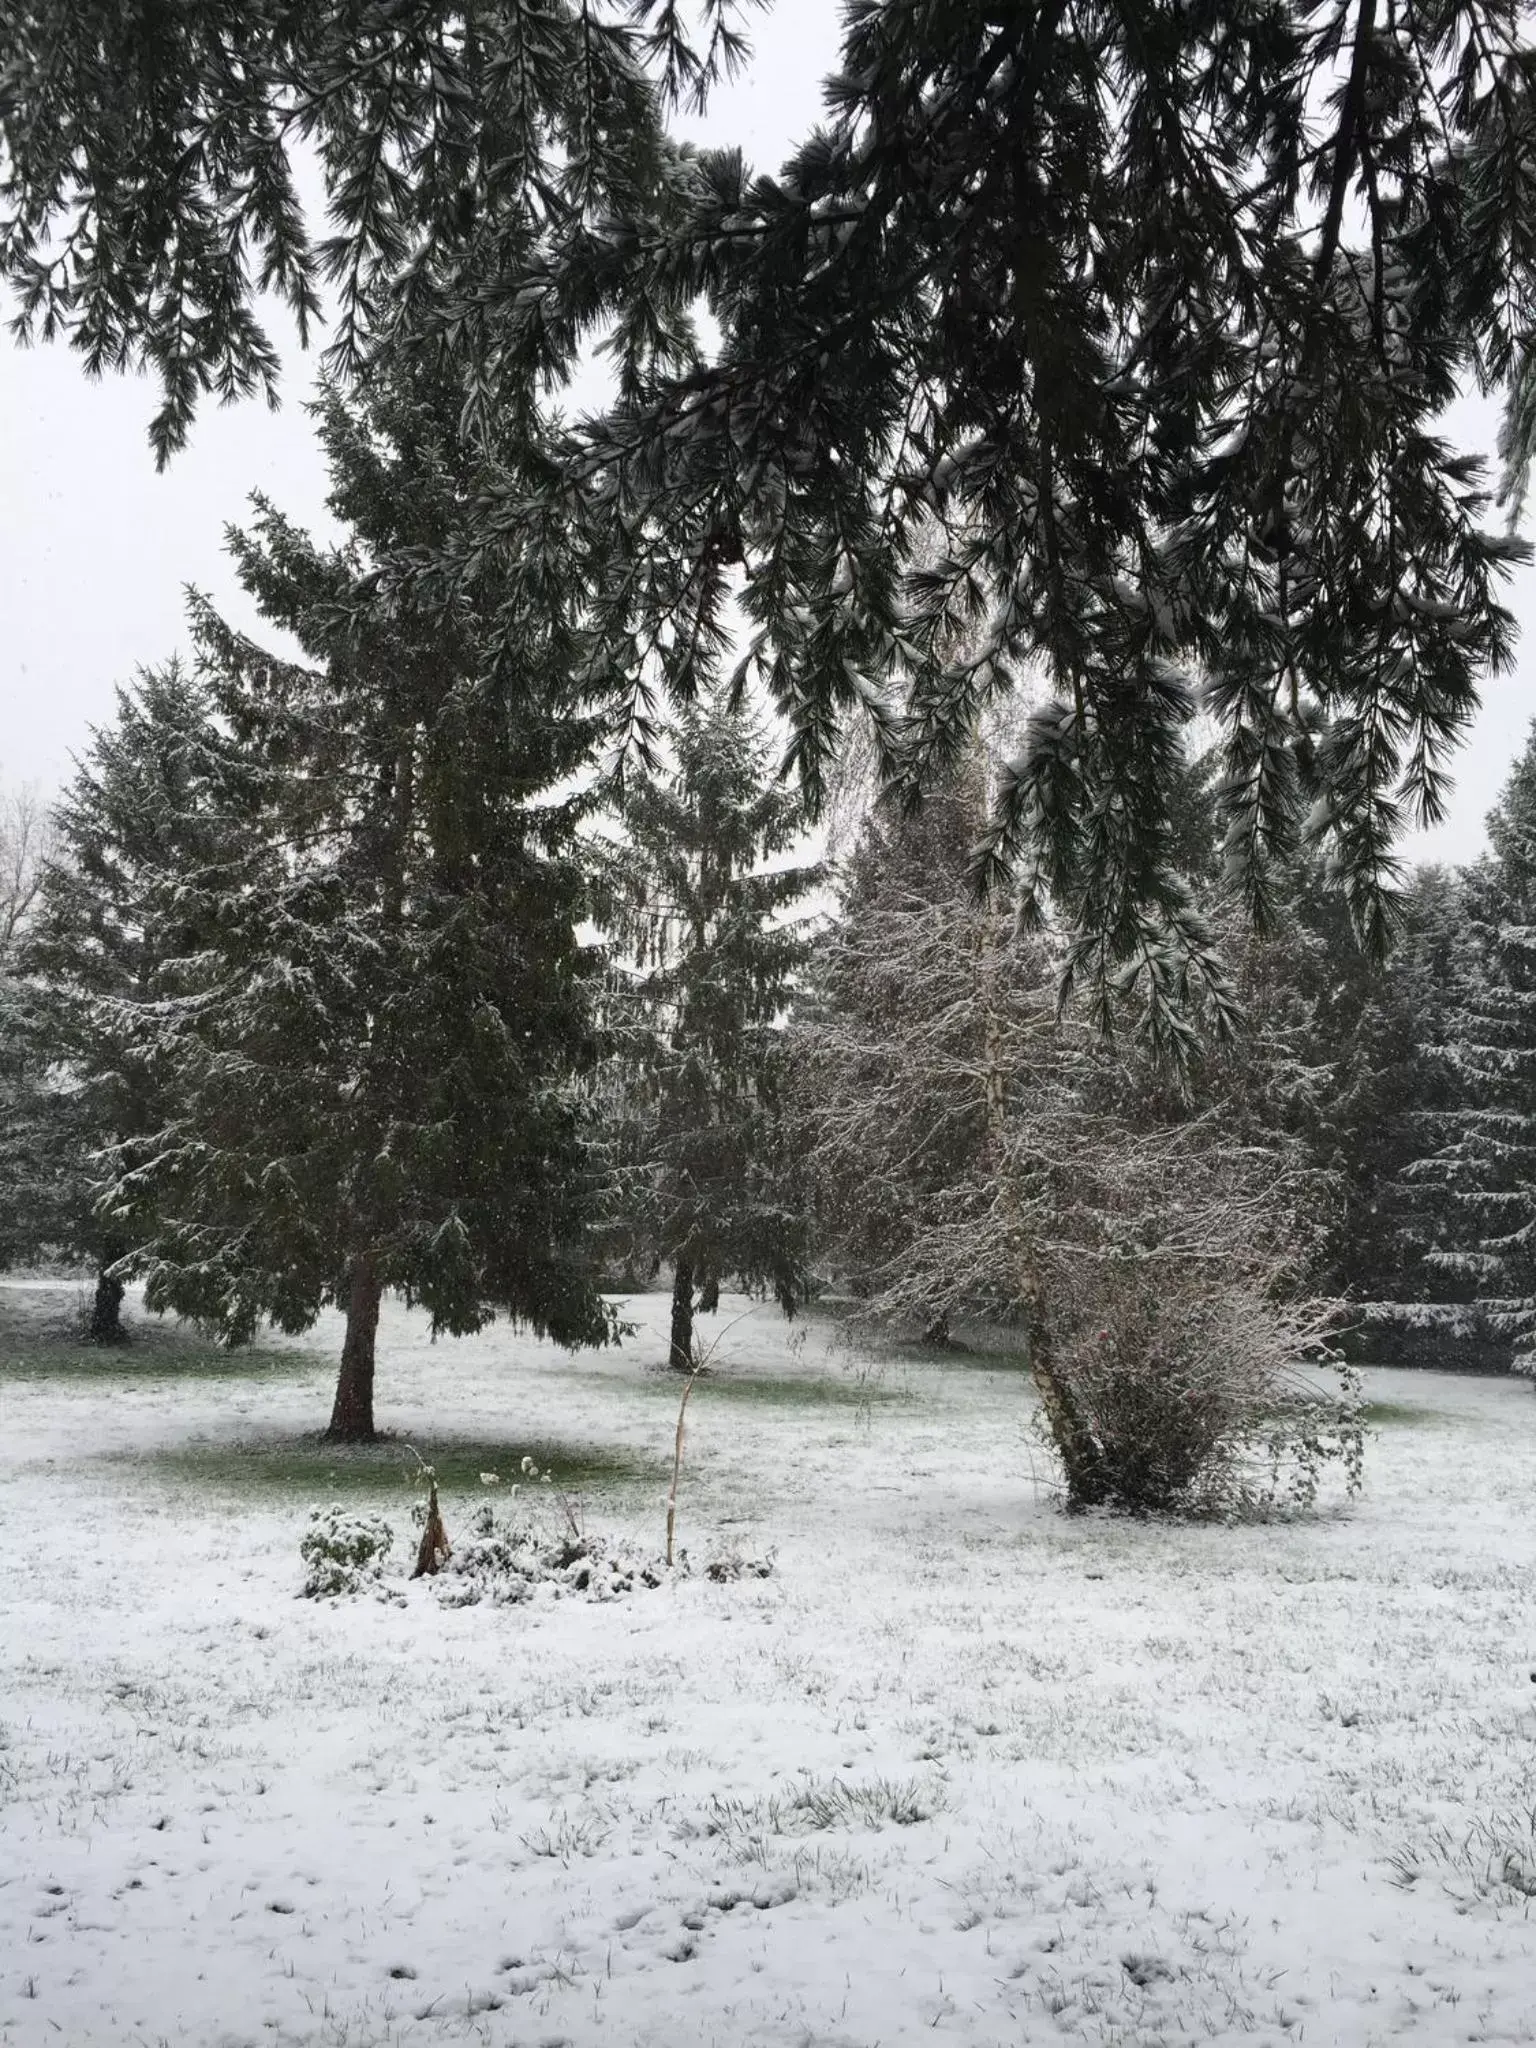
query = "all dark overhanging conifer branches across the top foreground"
xmin=0 ymin=0 xmax=1536 ymax=1018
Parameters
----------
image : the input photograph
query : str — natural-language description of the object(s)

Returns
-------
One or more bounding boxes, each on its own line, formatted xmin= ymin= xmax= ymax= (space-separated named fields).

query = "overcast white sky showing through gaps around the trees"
xmin=0 ymin=0 xmax=1536 ymax=860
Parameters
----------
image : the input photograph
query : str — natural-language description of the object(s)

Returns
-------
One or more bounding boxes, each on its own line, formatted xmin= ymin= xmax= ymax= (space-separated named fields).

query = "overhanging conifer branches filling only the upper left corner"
xmin=0 ymin=0 xmax=743 ymax=463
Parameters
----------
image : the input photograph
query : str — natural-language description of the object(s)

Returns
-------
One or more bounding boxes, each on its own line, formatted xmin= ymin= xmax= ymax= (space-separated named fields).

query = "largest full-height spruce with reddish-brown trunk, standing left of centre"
xmin=104 ymin=377 xmax=610 ymax=1440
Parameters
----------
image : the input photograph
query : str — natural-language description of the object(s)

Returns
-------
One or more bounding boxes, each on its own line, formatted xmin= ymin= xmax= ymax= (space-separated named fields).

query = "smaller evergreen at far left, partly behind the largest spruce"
xmin=20 ymin=662 xmax=217 ymax=1343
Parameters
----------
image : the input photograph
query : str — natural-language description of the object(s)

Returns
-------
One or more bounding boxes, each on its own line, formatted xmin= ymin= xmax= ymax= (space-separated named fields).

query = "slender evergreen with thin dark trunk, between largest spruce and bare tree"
xmin=600 ymin=700 xmax=819 ymax=1372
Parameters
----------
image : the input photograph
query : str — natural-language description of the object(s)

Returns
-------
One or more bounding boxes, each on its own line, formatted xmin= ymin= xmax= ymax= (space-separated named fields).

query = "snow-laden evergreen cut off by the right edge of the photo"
xmin=1405 ymin=727 xmax=1536 ymax=1374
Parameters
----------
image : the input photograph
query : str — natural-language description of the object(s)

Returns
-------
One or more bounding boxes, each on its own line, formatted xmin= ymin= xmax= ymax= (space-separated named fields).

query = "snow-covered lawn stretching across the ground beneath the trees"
xmin=0 ymin=1288 xmax=1536 ymax=2048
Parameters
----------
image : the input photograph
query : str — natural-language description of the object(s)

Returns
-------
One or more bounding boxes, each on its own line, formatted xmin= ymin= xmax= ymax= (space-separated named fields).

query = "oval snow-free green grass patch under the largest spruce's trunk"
xmin=111 ymin=1436 xmax=670 ymax=1507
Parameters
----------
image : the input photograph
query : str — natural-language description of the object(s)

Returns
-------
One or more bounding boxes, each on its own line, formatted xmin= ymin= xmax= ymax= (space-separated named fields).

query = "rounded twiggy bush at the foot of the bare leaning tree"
xmin=1042 ymin=1253 xmax=1364 ymax=1516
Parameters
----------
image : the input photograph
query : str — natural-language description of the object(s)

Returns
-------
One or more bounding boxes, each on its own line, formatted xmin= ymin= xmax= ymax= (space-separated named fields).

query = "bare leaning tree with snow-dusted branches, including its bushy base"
xmin=797 ymin=778 xmax=1360 ymax=1511
